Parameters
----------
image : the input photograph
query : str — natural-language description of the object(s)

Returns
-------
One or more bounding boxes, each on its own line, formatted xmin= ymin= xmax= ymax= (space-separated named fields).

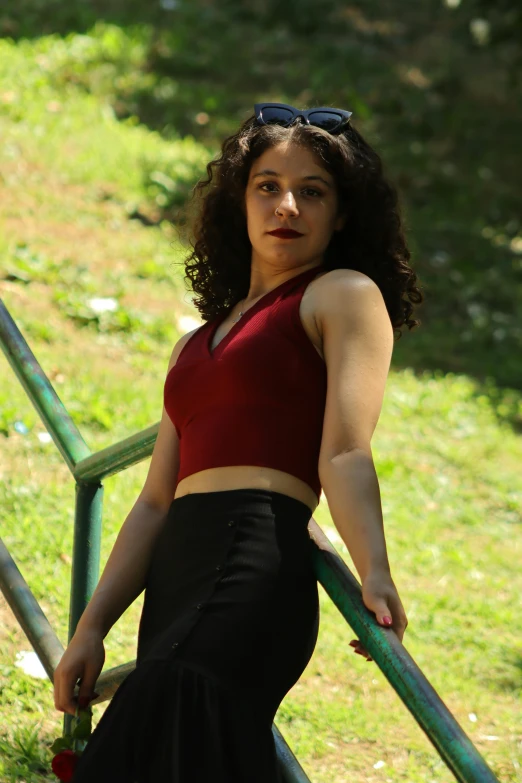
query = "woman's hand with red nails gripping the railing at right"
xmin=350 ymin=572 xmax=408 ymax=661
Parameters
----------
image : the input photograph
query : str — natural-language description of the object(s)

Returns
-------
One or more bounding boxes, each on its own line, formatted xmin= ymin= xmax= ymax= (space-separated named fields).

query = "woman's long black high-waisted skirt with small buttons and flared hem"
xmin=73 ymin=489 xmax=319 ymax=783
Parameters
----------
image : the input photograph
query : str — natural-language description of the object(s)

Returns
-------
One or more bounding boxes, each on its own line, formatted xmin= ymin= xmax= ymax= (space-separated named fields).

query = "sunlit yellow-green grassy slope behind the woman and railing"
xmin=0 ymin=33 xmax=522 ymax=783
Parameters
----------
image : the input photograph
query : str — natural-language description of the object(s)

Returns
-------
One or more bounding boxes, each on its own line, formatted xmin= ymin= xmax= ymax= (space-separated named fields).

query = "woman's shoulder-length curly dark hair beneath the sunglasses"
xmin=178 ymin=116 xmax=424 ymax=337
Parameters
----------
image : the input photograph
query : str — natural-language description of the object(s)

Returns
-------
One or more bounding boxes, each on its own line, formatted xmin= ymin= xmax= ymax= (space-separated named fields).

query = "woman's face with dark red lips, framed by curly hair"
xmin=245 ymin=142 xmax=346 ymax=269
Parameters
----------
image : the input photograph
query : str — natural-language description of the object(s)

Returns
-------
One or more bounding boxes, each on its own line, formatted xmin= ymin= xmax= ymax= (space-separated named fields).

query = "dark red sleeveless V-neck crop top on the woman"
xmin=164 ymin=267 xmax=327 ymax=499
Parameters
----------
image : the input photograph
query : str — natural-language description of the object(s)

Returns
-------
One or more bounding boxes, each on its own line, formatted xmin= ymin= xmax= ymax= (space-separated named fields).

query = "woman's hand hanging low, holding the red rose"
xmin=54 ymin=630 xmax=105 ymax=715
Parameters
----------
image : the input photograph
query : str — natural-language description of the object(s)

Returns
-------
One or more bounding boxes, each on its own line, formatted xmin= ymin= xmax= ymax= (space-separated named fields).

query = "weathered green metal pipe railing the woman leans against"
xmin=0 ymin=300 xmax=498 ymax=783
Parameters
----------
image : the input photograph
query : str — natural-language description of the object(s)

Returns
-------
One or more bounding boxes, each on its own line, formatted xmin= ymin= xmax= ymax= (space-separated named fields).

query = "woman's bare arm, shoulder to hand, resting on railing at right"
xmin=316 ymin=269 xmax=408 ymax=658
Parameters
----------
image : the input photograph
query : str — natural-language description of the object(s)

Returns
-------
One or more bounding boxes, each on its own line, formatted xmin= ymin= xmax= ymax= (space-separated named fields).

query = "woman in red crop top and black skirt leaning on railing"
xmin=54 ymin=104 xmax=422 ymax=783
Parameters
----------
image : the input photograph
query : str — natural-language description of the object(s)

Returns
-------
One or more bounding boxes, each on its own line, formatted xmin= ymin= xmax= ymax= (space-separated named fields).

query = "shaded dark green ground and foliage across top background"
xmin=0 ymin=0 xmax=522 ymax=392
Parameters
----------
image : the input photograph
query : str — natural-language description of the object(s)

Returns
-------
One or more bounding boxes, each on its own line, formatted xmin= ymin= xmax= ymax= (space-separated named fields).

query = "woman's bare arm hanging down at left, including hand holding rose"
xmin=54 ymin=327 xmax=199 ymax=715
